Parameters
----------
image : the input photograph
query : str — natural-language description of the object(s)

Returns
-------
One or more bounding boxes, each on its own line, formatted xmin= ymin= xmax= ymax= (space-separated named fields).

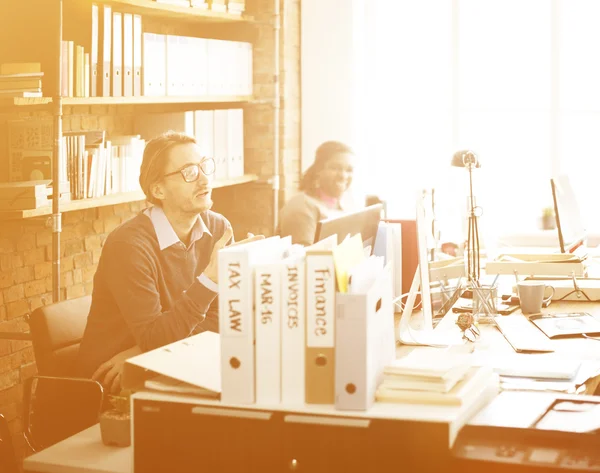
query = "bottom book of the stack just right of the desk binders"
xmin=375 ymin=366 xmax=499 ymax=406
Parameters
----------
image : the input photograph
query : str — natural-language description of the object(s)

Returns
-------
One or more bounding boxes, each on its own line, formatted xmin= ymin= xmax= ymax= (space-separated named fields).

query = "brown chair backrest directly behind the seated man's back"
xmin=29 ymin=296 xmax=92 ymax=377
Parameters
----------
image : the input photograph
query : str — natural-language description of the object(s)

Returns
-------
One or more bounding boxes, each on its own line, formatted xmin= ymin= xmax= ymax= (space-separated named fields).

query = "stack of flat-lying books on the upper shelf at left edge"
xmin=0 ymin=63 xmax=44 ymax=98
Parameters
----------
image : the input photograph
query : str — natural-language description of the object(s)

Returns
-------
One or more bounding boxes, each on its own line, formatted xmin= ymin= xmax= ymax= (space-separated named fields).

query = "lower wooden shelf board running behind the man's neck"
xmin=0 ymin=174 xmax=258 ymax=220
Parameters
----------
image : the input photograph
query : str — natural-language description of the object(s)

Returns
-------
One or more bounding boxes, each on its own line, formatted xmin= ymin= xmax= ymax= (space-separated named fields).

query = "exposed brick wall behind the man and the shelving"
xmin=0 ymin=0 xmax=300 ymax=458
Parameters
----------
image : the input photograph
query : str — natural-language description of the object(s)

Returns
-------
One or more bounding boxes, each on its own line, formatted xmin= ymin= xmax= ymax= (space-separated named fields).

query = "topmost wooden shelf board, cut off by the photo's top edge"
xmin=102 ymin=0 xmax=253 ymax=23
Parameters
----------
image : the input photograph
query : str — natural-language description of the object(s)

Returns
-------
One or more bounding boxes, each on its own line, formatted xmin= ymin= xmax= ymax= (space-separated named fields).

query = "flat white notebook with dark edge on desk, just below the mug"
xmin=529 ymin=312 xmax=600 ymax=339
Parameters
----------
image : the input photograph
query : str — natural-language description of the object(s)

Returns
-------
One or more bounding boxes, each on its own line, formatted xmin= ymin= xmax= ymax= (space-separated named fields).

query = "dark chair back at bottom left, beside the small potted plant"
xmin=23 ymin=376 xmax=104 ymax=452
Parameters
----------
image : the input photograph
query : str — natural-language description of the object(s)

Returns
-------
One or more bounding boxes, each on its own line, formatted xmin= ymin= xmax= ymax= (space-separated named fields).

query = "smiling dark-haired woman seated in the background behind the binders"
xmin=279 ymin=141 xmax=355 ymax=245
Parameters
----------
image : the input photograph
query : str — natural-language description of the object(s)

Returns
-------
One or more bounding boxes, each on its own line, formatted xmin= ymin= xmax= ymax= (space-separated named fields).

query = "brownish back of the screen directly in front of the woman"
xmin=315 ymin=204 xmax=383 ymax=253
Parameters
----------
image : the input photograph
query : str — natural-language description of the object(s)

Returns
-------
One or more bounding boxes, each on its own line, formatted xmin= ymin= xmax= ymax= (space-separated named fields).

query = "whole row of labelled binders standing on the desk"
xmin=218 ymin=235 xmax=395 ymax=410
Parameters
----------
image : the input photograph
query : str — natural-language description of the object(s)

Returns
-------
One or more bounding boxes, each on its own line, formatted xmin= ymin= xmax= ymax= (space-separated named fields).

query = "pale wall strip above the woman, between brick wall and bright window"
xmin=300 ymin=0 xmax=365 ymax=171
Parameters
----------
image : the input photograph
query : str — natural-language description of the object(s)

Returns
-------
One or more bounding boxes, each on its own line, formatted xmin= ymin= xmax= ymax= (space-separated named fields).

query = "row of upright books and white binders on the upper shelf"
xmin=61 ymin=4 xmax=252 ymax=97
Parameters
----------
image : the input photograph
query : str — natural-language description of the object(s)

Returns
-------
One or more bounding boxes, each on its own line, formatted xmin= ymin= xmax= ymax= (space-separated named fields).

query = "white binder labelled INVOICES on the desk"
xmin=281 ymin=248 xmax=306 ymax=404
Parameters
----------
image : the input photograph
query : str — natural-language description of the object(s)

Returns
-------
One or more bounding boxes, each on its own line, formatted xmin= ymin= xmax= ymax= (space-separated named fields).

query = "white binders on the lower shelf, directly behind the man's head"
xmin=134 ymin=108 xmax=244 ymax=179
